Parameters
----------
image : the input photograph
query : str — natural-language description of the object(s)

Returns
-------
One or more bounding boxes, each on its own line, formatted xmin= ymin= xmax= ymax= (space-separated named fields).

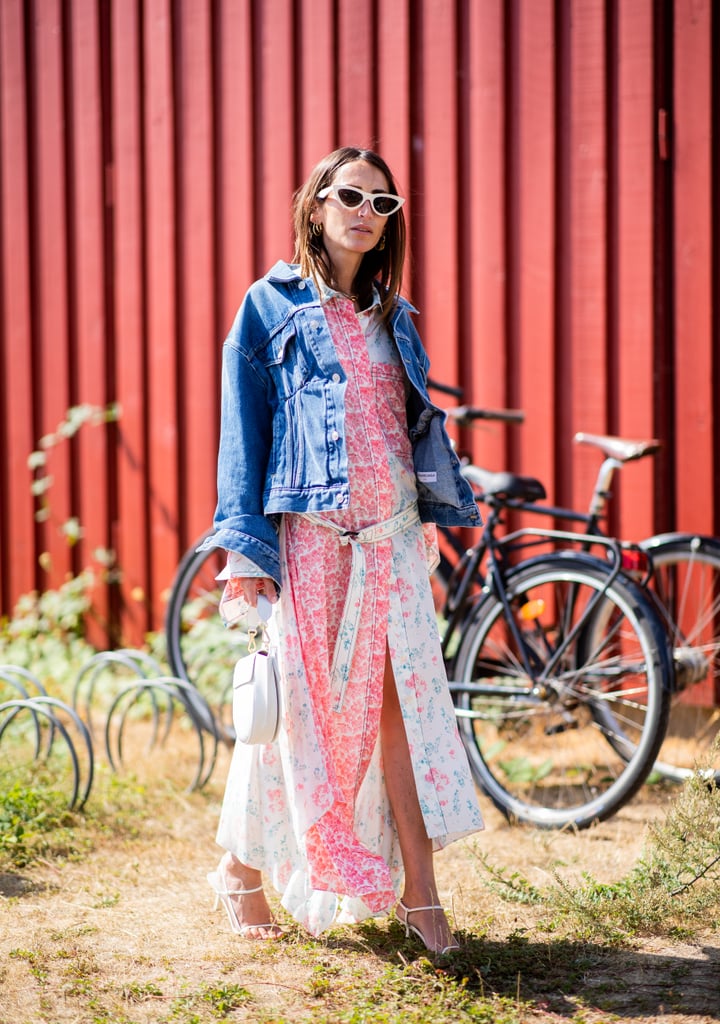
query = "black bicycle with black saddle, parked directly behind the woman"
xmin=167 ymin=413 xmax=672 ymax=827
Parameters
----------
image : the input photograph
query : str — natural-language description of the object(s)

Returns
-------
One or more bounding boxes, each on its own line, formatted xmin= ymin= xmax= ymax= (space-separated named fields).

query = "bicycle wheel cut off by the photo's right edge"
xmin=643 ymin=534 xmax=720 ymax=785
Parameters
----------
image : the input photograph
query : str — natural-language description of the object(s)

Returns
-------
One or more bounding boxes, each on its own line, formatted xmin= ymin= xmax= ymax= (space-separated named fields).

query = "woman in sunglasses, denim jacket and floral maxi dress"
xmin=206 ymin=147 xmax=482 ymax=952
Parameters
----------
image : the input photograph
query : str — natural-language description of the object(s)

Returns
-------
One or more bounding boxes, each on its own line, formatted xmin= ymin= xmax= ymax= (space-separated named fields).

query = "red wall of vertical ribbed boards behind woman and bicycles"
xmin=0 ymin=0 xmax=720 ymax=655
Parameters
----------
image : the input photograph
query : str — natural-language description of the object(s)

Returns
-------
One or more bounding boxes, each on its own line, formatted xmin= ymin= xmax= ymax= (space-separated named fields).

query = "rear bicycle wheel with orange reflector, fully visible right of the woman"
xmin=451 ymin=554 xmax=672 ymax=828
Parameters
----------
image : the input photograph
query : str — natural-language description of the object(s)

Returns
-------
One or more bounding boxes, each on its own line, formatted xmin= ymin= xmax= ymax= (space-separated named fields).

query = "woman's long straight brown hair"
xmin=293 ymin=145 xmax=407 ymax=319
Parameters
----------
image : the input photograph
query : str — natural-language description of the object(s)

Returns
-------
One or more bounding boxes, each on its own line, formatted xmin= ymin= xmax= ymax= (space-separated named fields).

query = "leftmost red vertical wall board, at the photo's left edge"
xmin=0 ymin=0 xmax=37 ymax=610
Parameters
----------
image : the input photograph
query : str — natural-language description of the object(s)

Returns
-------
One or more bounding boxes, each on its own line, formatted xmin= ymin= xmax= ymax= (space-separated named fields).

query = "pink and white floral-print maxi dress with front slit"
xmin=217 ymin=292 xmax=482 ymax=935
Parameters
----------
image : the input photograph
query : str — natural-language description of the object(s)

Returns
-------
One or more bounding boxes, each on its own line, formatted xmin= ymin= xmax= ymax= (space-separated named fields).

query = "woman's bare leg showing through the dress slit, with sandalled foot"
xmin=380 ymin=653 xmax=457 ymax=951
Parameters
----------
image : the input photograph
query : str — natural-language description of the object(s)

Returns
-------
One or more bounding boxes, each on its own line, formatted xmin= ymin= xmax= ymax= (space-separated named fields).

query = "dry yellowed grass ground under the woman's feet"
xmin=0 ymin=733 xmax=720 ymax=1024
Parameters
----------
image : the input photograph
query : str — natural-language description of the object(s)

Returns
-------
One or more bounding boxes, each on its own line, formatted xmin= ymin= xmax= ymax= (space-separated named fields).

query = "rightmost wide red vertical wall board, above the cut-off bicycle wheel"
xmin=673 ymin=0 xmax=717 ymax=530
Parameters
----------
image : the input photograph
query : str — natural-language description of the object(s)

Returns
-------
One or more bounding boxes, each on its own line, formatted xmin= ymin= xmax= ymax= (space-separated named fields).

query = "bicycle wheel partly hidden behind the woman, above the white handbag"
xmin=165 ymin=531 xmax=247 ymax=719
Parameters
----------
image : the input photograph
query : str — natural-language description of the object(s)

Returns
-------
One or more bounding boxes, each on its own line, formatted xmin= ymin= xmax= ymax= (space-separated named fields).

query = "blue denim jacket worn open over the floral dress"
xmin=203 ymin=261 xmax=480 ymax=583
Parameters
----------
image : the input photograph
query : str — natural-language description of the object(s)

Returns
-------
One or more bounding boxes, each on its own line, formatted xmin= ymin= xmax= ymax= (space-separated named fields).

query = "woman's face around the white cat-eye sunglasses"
xmin=310 ymin=160 xmax=388 ymax=265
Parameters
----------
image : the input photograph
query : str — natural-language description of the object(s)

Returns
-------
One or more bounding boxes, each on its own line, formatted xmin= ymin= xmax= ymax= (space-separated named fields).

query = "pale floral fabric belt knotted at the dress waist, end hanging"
xmin=301 ymin=505 xmax=420 ymax=712
